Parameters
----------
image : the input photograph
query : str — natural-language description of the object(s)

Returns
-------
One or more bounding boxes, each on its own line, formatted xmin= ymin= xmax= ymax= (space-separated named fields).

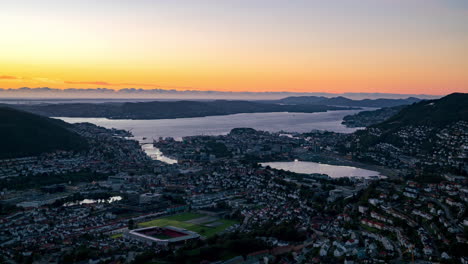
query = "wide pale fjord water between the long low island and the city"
xmin=58 ymin=109 xmax=367 ymax=142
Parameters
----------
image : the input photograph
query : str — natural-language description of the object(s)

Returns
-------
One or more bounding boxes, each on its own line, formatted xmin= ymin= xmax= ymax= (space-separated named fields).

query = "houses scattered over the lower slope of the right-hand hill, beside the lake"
xmin=348 ymin=121 xmax=468 ymax=172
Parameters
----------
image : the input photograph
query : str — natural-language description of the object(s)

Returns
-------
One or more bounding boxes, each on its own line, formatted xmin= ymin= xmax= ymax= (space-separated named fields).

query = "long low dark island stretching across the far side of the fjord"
xmin=7 ymin=100 xmax=351 ymax=119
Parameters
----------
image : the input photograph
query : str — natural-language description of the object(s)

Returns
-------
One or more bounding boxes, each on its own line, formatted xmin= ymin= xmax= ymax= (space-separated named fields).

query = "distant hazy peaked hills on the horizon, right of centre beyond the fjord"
xmin=274 ymin=96 xmax=421 ymax=108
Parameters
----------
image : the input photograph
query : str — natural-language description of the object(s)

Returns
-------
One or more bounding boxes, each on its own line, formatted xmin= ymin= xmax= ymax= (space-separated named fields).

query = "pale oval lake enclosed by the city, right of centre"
xmin=261 ymin=161 xmax=383 ymax=178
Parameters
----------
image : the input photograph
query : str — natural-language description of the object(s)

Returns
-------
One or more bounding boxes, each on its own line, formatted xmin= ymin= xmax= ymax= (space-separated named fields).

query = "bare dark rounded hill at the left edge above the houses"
xmin=0 ymin=107 xmax=87 ymax=159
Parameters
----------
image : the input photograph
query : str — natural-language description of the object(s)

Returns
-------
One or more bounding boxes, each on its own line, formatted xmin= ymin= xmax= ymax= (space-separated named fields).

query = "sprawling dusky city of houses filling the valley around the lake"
xmin=0 ymin=120 xmax=468 ymax=263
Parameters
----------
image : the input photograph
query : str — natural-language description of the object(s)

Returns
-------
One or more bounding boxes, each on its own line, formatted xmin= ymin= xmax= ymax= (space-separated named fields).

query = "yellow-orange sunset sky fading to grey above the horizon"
xmin=0 ymin=0 xmax=468 ymax=94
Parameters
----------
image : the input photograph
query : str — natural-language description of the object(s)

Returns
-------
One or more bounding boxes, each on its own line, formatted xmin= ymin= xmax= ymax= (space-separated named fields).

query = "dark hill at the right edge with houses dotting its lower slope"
xmin=345 ymin=93 xmax=468 ymax=174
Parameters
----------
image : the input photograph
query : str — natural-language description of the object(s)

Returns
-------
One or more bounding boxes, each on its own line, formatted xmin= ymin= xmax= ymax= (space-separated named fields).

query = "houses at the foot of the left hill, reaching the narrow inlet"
xmin=0 ymin=124 xmax=151 ymax=179
